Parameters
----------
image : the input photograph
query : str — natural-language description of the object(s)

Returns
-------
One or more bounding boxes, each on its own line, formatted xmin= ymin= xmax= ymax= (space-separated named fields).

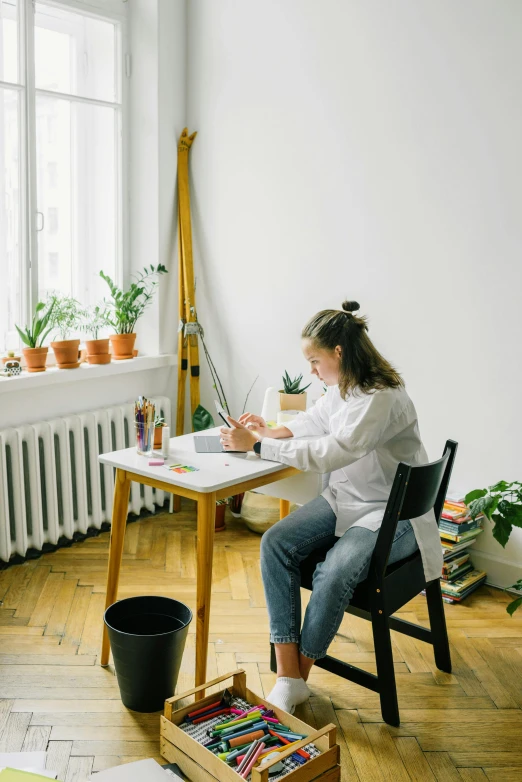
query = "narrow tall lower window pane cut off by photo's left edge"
xmin=0 ymin=89 xmax=21 ymax=350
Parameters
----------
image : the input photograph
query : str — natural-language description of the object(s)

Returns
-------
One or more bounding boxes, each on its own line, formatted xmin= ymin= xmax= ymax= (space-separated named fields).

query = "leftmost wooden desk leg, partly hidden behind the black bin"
xmin=100 ymin=470 xmax=130 ymax=665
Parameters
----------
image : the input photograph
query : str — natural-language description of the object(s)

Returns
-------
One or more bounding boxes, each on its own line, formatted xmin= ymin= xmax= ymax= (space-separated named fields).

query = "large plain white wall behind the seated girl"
xmin=188 ymin=0 xmax=522 ymax=584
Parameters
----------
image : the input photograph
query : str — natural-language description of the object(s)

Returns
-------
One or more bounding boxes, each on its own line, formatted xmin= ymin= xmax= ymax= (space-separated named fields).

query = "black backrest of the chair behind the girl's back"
xmin=370 ymin=440 xmax=458 ymax=578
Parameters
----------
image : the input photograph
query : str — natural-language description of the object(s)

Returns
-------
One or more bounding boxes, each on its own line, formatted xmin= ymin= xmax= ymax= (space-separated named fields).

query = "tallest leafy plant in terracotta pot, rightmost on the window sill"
xmin=100 ymin=263 xmax=167 ymax=360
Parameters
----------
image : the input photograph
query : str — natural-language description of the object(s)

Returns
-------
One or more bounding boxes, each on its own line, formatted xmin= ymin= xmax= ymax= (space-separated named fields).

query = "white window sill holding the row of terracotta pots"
xmin=0 ymin=353 xmax=177 ymax=395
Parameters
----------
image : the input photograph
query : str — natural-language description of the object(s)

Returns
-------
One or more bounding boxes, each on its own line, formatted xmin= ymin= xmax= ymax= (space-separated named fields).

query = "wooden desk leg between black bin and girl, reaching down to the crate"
xmin=196 ymin=492 xmax=216 ymax=700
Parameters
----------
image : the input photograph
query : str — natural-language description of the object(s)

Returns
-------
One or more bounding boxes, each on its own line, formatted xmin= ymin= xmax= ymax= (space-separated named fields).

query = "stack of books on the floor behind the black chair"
xmin=439 ymin=497 xmax=486 ymax=603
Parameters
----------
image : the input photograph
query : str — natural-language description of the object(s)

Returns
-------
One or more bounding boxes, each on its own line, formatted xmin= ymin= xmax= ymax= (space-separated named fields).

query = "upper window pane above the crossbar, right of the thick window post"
xmin=34 ymin=3 xmax=120 ymax=103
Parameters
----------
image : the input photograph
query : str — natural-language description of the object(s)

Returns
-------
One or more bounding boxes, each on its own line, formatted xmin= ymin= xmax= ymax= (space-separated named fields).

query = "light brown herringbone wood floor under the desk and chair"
xmin=0 ymin=501 xmax=522 ymax=782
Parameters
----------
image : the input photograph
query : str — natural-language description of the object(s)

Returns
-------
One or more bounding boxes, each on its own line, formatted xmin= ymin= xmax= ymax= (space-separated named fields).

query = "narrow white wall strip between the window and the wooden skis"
xmin=128 ymin=0 xmax=186 ymax=354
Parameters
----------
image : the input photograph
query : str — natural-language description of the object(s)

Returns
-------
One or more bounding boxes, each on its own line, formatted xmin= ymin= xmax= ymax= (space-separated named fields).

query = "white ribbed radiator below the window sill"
xmin=0 ymin=397 xmax=170 ymax=562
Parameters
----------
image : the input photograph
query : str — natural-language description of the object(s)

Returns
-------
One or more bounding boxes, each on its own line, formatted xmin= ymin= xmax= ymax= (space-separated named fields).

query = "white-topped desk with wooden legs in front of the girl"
xmin=99 ymin=427 xmax=299 ymax=698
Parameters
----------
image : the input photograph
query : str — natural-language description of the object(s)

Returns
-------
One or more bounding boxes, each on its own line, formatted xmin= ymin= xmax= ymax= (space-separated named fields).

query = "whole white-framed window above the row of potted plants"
xmin=0 ymin=0 xmax=123 ymax=350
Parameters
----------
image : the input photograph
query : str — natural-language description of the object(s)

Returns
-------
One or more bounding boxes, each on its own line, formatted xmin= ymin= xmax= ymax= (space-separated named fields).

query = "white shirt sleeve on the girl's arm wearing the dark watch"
xmin=261 ymin=389 xmax=402 ymax=473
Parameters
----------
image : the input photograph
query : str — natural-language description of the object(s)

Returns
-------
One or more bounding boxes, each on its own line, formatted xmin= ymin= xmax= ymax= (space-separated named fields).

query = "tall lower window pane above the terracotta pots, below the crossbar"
xmin=36 ymin=96 xmax=120 ymax=304
